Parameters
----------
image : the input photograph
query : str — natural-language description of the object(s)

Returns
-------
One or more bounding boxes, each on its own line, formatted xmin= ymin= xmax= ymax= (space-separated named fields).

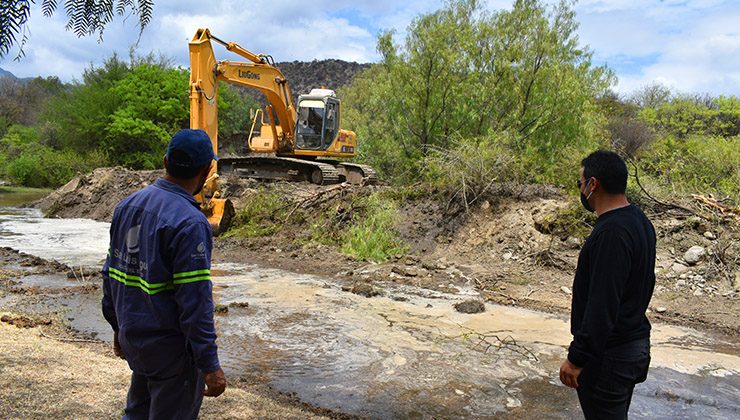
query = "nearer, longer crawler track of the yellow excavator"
xmin=218 ymin=155 xmax=341 ymax=185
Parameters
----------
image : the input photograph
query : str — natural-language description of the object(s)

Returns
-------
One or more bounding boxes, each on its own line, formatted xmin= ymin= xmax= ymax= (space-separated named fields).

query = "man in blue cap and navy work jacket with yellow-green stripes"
xmin=102 ymin=130 xmax=226 ymax=419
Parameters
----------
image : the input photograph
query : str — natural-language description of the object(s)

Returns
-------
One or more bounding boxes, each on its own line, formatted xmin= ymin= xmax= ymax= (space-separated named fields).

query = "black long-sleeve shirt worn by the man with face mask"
xmin=568 ymin=205 xmax=655 ymax=367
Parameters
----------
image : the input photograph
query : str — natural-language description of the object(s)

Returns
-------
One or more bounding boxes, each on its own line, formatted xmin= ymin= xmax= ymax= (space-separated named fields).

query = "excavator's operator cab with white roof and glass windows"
xmin=295 ymin=89 xmax=339 ymax=150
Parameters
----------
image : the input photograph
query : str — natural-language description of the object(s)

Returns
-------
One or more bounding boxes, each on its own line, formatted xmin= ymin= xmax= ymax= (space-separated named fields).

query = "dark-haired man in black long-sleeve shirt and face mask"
xmin=560 ymin=151 xmax=655 ymax=419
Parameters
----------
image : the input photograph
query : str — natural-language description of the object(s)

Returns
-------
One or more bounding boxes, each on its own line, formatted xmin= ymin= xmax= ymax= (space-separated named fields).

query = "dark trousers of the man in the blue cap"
xmin=123 ymin=354 xmax=205 ymax=420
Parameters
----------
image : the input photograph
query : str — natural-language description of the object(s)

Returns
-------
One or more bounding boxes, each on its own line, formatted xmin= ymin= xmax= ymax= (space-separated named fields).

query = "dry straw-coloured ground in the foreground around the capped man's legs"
xmin=0 ymin=312 xmax=326 ymax=419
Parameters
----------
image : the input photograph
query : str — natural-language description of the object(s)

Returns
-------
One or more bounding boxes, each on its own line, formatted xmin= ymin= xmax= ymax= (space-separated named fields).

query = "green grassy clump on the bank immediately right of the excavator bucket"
xmin=224 ymin=190 xmax=286 ymax=238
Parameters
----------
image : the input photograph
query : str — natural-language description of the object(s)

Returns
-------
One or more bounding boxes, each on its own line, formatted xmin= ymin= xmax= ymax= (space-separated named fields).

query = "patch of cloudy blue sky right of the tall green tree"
xmin=577 ymin=0 xmax=740 ymax=95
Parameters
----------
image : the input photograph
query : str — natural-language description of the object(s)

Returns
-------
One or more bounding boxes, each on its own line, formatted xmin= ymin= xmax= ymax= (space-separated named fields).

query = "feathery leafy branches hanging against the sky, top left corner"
xmin=0 ymin=0 xmax=154 ymax=60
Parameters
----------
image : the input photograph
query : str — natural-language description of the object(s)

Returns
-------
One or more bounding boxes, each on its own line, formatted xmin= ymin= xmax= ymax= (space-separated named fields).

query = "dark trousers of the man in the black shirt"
xmin=577 ymin=338 xmax=650 ymax=420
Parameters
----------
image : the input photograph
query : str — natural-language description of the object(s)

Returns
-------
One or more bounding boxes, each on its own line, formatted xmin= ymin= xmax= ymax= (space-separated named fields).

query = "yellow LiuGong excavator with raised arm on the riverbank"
xmin=189 ymin=29 xmax=376 ymax=234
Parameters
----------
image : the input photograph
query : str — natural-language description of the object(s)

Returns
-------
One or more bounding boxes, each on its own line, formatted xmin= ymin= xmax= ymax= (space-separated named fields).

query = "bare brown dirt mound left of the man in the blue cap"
xmin=34 ymin=167 xmax=164 ymax=222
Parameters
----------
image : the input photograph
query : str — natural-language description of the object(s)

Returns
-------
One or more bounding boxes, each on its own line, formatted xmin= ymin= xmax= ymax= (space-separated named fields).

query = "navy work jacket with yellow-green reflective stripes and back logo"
xmin=102 ymin=179 xmax=220 ymax=375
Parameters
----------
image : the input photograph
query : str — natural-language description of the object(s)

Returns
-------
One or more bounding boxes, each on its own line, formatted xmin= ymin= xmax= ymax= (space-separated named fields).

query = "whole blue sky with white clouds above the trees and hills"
xmin=0 ymin=0 xmax=740 ymax=96
